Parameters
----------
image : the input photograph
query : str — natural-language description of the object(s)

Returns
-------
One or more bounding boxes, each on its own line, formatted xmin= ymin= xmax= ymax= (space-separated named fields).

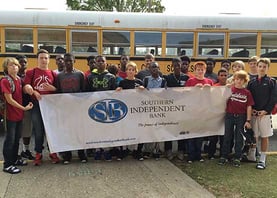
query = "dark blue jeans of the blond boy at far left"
xmin=3 ymin=120 xmax=22 ymax=168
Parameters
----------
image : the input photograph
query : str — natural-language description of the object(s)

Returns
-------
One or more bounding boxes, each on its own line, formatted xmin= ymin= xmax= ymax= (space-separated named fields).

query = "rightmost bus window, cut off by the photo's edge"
xmin=261 ymin=33 xmax=277 ymax=58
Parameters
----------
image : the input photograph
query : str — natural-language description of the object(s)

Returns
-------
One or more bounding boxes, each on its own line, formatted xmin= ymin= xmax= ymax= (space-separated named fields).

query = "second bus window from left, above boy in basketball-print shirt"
xmin=38 ymin=29 xmax=66 ymax=53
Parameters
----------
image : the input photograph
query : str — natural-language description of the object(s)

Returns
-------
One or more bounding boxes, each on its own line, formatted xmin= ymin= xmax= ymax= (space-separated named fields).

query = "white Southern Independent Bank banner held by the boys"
xmin=40 ymin=87 xmax=231 ymax=152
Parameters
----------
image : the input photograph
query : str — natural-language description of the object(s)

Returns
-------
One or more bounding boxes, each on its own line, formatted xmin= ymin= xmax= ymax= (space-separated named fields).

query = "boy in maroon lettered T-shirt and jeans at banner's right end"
xmin=219 ymin=70 xmax=254 ymax=167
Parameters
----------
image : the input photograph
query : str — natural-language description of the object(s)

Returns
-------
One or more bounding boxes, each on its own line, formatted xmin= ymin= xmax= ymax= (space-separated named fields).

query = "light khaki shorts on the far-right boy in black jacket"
xmin=251 ymin=115 xmax=273 ymax=138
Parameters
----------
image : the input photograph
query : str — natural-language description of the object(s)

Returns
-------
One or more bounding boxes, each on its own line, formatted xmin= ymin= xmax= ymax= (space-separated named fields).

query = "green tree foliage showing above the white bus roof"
xmin=66 ymin=0 xmax=165 ymax=12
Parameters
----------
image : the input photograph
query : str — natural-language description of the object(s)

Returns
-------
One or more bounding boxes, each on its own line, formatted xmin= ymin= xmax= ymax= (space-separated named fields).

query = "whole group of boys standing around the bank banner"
xmin=1 ymin=50 xmax=277 ymax=174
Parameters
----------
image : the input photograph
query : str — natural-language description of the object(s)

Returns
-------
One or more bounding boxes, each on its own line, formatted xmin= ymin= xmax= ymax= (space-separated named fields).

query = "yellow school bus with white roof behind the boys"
xmin=0 ymin=10 xmax=277 ymax=77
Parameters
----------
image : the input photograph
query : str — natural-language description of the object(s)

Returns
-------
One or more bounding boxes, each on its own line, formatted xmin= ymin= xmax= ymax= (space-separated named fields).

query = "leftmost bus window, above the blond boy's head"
xmin=5 ymin=28 xmax=33 ymax=53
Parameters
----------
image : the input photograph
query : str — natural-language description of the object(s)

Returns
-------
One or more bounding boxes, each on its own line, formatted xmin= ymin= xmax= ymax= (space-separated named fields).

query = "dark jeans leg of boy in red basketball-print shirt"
xmin=31 ymin=102 xmax=45 ymax=153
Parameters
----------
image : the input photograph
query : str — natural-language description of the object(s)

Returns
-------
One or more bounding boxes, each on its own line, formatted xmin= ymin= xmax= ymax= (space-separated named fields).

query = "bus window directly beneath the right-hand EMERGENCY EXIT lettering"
xmin=198 ymin=33 xmax=225 ymax=56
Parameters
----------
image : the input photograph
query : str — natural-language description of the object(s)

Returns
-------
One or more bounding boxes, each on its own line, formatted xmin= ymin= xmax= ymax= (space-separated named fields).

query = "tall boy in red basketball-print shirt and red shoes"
xmin=24 ymin=49 xmax=59 ymax=166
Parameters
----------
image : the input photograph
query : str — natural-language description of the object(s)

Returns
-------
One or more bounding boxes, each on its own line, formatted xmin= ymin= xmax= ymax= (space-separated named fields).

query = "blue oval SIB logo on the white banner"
xmin=88 ymin=99 xmax=128 ymax=123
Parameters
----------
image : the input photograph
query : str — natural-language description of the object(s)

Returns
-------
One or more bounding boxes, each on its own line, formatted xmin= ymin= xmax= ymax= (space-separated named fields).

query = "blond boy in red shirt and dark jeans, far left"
xmin=1 ymin=58 xmax=33 ymax=174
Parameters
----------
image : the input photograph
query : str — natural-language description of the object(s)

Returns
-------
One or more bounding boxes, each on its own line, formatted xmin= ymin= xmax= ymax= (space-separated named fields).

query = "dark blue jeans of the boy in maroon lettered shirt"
xmin=222 ymin=113 xmax=246 ymax=159
